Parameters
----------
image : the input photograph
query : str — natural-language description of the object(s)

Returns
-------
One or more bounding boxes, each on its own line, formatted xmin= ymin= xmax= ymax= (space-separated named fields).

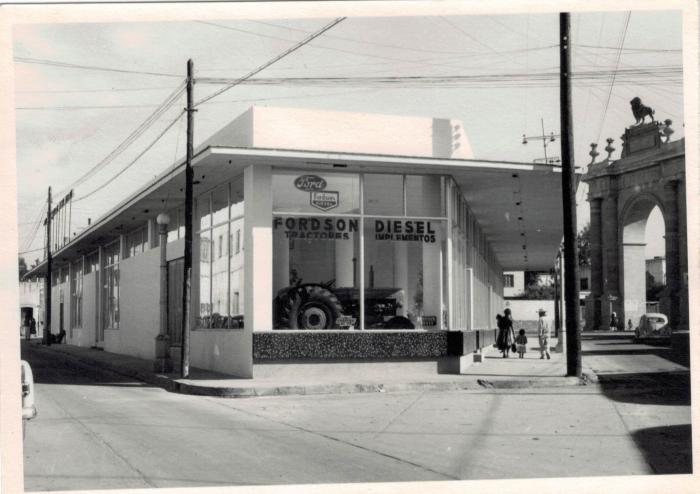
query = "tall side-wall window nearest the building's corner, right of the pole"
xmin=195 ymin=178 xmax=243 ymax=328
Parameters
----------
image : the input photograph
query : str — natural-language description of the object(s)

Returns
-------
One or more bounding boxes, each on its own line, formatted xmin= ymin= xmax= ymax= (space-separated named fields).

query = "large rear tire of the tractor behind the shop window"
xmin=279 ymin=285 xmax=343 ymax=330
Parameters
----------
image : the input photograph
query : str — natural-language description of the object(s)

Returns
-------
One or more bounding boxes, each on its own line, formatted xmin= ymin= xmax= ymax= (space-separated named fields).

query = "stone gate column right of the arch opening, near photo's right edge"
xmin=664 ymin=180 xmax=681 ymax=330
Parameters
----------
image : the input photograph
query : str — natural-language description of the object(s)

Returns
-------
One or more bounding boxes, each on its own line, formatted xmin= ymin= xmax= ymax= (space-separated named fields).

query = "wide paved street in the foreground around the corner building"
xmin=23 ymin=338 xmax=690 ymax=490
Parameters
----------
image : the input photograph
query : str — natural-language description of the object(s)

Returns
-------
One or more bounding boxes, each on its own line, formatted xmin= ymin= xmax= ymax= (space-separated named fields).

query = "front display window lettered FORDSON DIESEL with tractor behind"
xmin=272 ymin=171 xmax=447 ymax=330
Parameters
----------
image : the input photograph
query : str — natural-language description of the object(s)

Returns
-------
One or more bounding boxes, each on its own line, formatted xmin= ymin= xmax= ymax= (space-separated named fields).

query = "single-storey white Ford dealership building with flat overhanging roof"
xmin=28 ymin=107 xmax=562 ymax=377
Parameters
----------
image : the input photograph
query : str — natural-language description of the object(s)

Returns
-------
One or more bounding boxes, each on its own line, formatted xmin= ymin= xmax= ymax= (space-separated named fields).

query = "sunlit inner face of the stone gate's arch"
xmin=619 ymin=192 xmax=667 ymax=325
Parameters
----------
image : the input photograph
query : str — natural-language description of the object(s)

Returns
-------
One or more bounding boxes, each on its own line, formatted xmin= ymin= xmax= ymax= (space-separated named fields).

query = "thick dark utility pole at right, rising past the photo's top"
xmin=559 ymin=12 xmax=581 ymax=377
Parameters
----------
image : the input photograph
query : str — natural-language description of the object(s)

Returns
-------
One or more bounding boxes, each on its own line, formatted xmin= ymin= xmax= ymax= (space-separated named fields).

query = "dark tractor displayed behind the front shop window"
xmin=274 ymin=280 xmax=415 ymax=329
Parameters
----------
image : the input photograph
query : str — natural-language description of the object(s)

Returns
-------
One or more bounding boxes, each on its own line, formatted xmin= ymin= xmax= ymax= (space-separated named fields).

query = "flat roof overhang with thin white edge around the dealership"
xmin=26 ymin=146 xmax=576 ymax=277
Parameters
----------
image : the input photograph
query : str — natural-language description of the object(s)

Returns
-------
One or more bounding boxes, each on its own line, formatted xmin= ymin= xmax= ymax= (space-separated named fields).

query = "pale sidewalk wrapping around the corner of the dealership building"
xmin=22 ymin=339 xmax=597 ymax=398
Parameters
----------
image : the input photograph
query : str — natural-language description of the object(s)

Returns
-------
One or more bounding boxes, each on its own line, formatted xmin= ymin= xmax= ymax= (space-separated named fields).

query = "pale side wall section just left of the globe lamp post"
xmin=105 ymin=249 xmax=160 ymax=359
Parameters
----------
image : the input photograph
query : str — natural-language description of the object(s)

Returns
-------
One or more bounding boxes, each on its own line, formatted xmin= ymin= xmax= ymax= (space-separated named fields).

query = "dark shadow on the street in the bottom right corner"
xmin=632 ymin=425 xmax=693 ymax=474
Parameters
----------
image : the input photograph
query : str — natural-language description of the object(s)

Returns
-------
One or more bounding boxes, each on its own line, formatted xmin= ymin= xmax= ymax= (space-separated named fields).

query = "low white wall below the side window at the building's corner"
xmin=190 ymin=329 xmax=253 ymax=378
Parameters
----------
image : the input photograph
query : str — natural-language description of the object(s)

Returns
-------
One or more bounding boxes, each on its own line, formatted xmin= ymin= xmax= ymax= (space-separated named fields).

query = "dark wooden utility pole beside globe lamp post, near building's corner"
xmin=180 ymin=59 xmax=195 ymax=378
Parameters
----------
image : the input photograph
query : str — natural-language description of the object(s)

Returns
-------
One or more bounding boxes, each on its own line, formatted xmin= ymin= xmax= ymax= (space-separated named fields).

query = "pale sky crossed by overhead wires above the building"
xmin=13 ymin=5 xmax=684 ymax=264
